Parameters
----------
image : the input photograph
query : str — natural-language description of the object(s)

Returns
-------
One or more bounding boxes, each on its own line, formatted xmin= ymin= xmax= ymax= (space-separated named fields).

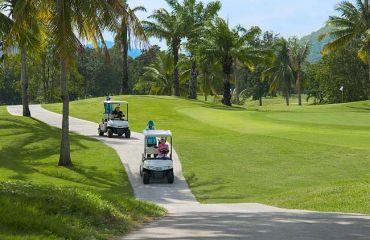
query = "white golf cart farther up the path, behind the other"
xmin=98 ymin=100 xmax=131 ymax=138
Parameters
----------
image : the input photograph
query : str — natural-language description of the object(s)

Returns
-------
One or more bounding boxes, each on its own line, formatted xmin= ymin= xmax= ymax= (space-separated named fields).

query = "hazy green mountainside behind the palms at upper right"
xmin=301 ymin=27 xmax=331 ymax=63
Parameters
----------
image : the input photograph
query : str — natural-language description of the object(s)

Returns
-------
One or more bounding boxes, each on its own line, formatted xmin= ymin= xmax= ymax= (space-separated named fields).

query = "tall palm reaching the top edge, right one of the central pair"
xmin=182 ymin=0 xmax=221 ymax=99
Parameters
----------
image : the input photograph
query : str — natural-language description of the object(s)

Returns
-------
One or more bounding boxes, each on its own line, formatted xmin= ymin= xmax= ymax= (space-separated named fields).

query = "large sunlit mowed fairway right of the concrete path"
xmin=45 ymin=96 xmax=370 ymax=213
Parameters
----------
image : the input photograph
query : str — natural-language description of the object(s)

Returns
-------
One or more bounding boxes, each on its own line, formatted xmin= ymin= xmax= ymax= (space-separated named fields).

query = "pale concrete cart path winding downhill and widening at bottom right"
xmin=8 ymin=105 xmax=370 ymax=240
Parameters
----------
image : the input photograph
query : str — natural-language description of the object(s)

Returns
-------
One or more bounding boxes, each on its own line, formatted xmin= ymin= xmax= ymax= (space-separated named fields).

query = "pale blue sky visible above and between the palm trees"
xmin=106 ymin=0 xmax=340 ymax=46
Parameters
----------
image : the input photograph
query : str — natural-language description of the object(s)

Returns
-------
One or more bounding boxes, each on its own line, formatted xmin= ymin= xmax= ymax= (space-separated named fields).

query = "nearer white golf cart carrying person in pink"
xmin=140 ymin=130 xmax=174 ymax=184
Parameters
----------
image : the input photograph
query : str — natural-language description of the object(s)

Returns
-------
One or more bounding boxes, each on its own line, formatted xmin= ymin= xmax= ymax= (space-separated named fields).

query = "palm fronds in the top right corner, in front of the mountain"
xmin=320 ymin=0 xmax=370 ymax=93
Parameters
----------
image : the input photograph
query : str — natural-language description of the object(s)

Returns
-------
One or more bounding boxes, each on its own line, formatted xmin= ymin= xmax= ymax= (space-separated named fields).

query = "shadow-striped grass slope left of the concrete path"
xmin=0 ymin=107 xmax=164 ymax=239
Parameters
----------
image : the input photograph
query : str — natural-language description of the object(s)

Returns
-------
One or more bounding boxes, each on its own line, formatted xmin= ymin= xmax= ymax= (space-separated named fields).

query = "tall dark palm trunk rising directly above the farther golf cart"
xmin=121 ymin=20 xmax=130 ymax=94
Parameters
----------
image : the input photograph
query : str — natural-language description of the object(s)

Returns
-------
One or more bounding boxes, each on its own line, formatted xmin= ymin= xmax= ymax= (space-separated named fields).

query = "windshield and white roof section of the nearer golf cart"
xmin=143 ymin=130 xmax=172 ymax=159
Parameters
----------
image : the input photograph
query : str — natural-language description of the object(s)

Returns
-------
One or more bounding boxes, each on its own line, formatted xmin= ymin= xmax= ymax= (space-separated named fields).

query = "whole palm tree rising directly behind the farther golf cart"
xmin=115 ymin=0 xmax=148 ymax=94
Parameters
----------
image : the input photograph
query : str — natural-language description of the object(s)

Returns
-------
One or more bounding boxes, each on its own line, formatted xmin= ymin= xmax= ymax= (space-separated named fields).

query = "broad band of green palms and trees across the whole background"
xmin=0 ymin=0 xmax=369 ymax=108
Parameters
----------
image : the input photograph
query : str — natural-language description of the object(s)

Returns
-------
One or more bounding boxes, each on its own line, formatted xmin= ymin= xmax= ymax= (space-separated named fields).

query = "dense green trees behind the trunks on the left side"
xmin=0 ymin=46 xmax=160 ymax=104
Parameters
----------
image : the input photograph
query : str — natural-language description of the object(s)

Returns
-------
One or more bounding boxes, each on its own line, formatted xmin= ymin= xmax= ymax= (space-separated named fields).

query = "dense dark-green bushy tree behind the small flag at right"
xmin=306 ymin=40 xmax=370 ymax=103
